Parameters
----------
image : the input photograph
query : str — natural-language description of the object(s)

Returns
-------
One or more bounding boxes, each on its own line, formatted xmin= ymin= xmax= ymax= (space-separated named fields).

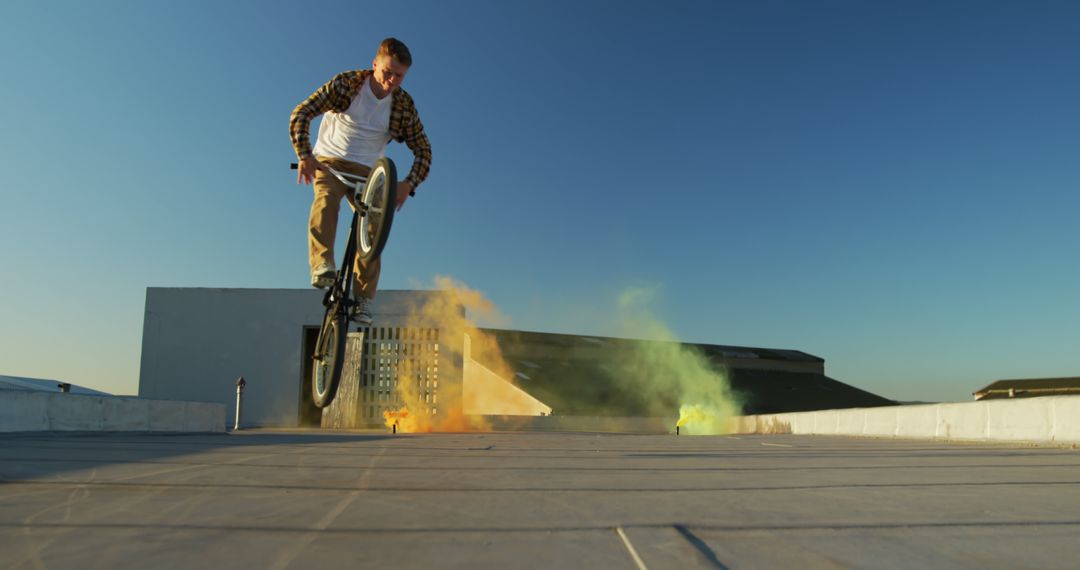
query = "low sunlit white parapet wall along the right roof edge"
xmin=734 ymin=396 xmax=1080 ymax=443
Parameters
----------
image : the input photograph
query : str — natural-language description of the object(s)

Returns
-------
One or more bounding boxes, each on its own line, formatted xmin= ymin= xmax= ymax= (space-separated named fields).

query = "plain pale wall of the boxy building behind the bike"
xmin=138 ymin=287 xmax=445 ymax=426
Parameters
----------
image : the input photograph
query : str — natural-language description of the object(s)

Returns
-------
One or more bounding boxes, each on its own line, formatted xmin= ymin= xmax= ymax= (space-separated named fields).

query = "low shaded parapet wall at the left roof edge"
xmin=0 ymin=390 xmax=226 ymax=433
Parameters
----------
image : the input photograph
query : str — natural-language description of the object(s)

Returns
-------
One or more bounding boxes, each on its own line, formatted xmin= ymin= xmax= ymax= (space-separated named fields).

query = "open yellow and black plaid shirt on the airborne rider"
xmin=288 ymin=69 xmax=431 ymax=188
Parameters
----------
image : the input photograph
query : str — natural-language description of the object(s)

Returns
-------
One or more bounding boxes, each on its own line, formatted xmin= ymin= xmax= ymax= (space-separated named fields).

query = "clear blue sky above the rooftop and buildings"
xmin=0 ymin=0 xmax=1080 ymax=401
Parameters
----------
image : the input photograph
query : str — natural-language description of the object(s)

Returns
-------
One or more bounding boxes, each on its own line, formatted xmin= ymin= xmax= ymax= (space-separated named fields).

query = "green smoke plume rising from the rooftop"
xmin=617 ymin=288 xmax=742 ymax=435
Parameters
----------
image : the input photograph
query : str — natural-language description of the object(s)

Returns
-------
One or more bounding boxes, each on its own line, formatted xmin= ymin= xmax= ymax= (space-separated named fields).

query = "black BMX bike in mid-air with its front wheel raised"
xmin=292 ymin=157 xmax=397 ymax=408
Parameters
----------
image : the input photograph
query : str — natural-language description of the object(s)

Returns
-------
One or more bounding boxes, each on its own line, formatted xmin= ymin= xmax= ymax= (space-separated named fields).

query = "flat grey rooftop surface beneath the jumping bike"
xmin=0 ymin=431 xmax=1080 ymax=569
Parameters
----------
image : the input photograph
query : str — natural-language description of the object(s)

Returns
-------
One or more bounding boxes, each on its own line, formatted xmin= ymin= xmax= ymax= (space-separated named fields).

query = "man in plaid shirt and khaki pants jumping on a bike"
xmin=288 ymin=38 xmax=431 ymax=325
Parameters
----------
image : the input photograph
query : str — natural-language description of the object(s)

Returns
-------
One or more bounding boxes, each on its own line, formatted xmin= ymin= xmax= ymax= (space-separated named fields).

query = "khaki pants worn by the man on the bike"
xmin=308 ymin=157 xmax=382 ymax=299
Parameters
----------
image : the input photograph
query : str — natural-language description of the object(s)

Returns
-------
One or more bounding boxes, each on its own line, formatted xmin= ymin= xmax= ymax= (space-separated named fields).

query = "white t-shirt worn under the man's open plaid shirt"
xmin=312 ymin=78 xmax=393 ymax=166
